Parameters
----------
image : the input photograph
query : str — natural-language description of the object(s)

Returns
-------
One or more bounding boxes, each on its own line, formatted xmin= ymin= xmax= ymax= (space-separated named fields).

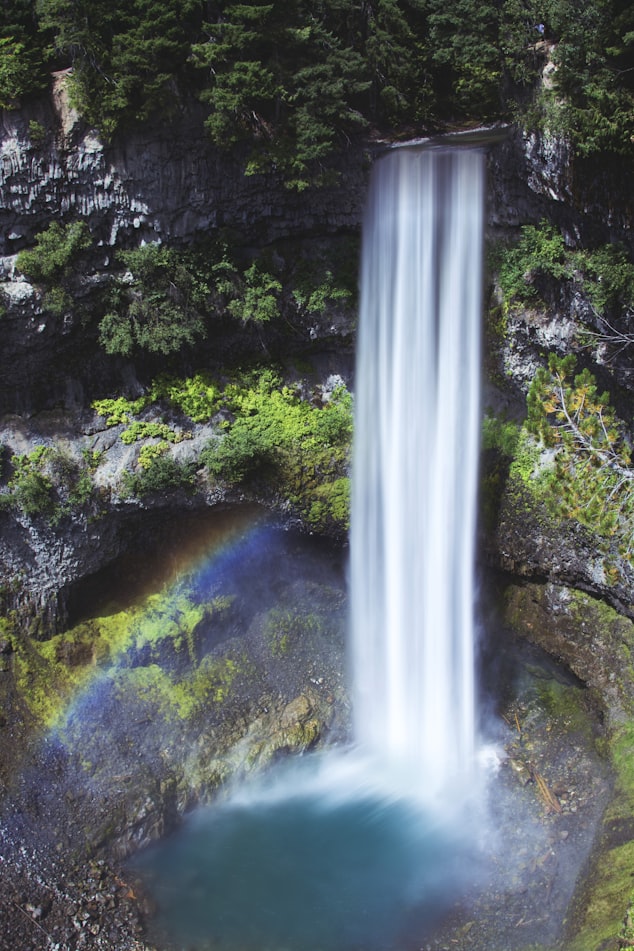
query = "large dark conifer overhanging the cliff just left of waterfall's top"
xmin=193 ymin=0 xmax=369 ymax=188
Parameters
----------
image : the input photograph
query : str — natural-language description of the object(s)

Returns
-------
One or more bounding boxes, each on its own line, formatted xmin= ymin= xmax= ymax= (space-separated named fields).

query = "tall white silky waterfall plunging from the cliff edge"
xmin=351 ymin=147 xmax=484 ymax=799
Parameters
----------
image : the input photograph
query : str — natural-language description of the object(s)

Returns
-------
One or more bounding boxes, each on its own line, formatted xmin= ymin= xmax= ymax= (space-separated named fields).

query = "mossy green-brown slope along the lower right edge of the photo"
xmin=507 ymin=585 xmax=634 ymax=951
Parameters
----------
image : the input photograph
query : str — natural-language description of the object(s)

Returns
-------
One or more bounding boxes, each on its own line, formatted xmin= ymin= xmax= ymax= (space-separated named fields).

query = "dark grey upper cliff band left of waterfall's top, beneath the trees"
xmin=0 ymin=74 xmax=365 ymax=255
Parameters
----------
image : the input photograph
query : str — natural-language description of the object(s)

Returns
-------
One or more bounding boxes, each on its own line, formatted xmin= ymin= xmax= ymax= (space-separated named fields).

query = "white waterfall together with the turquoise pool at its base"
xmin=131 ymin=148 xmax=484 ymax=951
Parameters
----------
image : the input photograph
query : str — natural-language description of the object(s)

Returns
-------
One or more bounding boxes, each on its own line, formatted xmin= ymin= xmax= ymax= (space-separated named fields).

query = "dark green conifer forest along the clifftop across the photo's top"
xmin=0 ymin=0 xmax=634 ymax=173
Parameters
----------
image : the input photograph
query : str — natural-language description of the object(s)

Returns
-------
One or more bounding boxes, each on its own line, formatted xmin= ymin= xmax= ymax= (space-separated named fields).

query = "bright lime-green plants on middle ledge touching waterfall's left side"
xmin=93 ymin=370 xmax=352 ymax=531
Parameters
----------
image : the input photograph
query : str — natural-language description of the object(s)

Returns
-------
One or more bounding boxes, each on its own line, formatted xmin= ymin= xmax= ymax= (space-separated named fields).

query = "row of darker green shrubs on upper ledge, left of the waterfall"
xmin=93 ymin=240 xmax=356 ymax=357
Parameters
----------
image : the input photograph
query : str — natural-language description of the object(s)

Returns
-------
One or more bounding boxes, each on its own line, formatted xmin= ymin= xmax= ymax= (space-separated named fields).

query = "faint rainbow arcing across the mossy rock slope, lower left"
xmin=26 ymin=506 xmax=272 ymax=746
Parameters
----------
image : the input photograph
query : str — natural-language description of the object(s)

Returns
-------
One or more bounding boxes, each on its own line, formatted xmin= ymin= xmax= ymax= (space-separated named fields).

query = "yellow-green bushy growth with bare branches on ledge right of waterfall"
xmin=482 ymin=354 xmax=634 ymax=577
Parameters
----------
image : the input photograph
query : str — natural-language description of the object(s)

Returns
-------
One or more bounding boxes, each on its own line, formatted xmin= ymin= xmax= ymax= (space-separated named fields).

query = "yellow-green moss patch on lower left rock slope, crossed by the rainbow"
xmin=15 ymin=586 xmax=242 ymax=728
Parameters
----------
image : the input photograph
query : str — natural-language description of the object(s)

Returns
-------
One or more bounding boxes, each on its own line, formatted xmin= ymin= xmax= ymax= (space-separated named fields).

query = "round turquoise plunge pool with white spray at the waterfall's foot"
xmin=135 ymin=754 xmax=474 ymax=951
